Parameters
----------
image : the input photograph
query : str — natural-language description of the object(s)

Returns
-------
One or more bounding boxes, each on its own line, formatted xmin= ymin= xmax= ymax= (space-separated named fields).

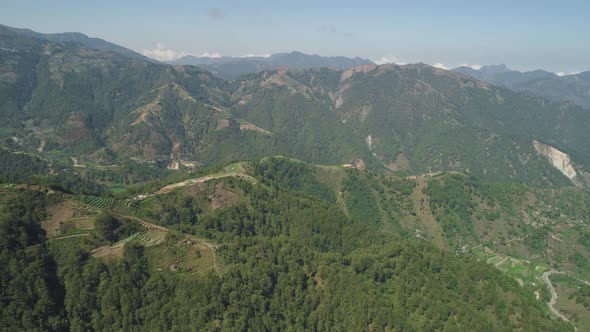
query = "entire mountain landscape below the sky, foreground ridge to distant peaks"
xmin=0 ymin=26 xmax=590 ymax=331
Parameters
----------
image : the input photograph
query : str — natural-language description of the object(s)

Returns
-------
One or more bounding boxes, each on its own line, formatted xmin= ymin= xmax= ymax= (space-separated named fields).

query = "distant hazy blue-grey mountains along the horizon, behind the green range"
xmin=6 ymin=25 xmax=590 ymax=107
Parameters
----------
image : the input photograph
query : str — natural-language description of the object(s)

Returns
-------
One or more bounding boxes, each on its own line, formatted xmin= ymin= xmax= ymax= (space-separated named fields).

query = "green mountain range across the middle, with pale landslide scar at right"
xmin=0 ymin=24 xmax=590 ymax=186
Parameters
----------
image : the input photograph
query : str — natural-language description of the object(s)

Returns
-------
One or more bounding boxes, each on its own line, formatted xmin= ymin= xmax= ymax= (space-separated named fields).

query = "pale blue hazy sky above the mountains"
xmin=0 ymin=0 xmax=590 ymax=74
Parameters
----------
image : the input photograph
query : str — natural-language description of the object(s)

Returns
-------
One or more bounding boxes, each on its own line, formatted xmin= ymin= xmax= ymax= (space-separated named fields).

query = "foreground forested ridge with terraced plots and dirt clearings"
xmin=0 ymin=158 xmax=571 ymax=331
